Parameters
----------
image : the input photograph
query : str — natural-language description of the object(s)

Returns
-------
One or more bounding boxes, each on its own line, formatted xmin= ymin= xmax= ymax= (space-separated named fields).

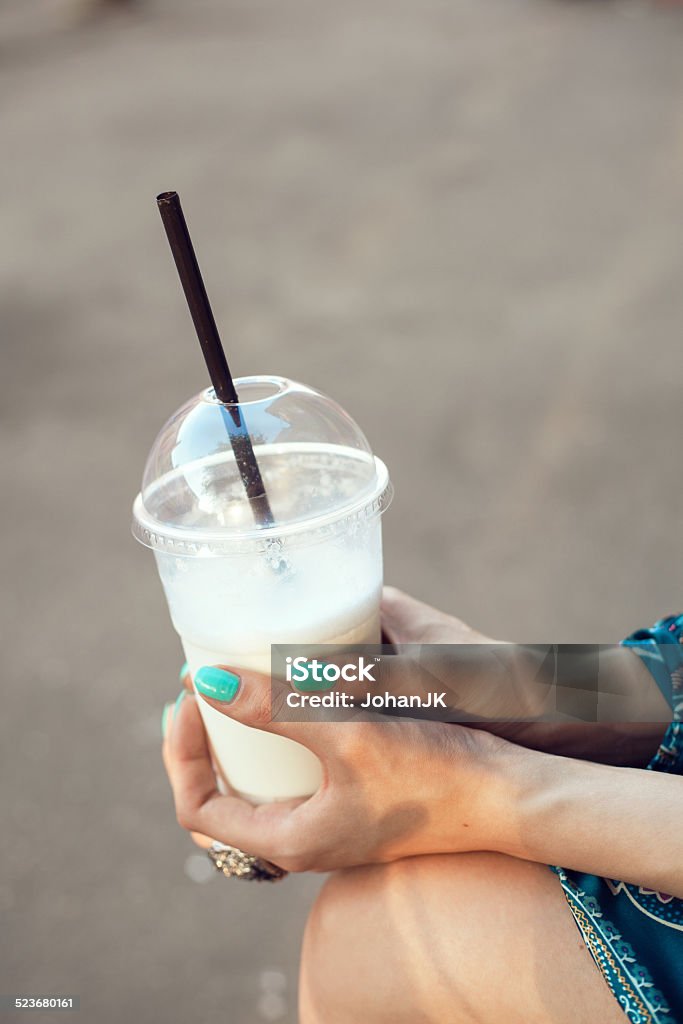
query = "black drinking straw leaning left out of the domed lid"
xmin=157 ymin=193 xmax=273 ymax=526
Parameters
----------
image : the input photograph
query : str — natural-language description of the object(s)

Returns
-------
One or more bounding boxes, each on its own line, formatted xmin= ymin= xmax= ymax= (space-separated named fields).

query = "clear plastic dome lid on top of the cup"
xmin=133 ymin=377 xmax=392 ymax=556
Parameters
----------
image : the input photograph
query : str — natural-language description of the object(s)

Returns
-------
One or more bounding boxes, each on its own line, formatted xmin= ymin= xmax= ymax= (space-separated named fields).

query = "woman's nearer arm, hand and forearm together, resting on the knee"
xmin=164 ymin=671 xmax=683 ymax=897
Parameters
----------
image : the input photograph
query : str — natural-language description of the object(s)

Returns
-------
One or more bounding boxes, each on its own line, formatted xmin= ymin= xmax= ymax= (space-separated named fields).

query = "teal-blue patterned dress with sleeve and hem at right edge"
xmin=553 ymin=615 xmax=683 ymax=1024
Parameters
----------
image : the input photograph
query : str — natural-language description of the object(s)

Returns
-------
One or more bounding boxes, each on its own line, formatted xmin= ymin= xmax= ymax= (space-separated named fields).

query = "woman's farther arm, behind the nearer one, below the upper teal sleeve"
xmin=382 ymin=587 xmax=671 ymax=768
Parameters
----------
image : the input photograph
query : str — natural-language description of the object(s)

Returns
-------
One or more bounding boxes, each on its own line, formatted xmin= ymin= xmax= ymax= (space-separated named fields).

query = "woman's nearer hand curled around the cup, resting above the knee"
xmin=164 ymin=670 xmax=514 ymax=871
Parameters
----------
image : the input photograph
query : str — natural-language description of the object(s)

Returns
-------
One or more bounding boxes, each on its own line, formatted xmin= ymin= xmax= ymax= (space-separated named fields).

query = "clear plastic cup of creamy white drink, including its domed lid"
xmin=133 ymin=377 xmax=392 ymax=803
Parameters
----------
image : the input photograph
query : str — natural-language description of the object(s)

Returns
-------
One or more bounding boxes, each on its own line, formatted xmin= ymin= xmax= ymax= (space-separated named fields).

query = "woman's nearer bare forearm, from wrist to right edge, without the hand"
xmin=491 ymin=748 xmax=683 ymax=898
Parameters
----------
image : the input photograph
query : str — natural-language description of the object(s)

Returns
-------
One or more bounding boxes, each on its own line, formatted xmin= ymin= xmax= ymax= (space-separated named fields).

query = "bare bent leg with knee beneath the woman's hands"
xmin=301 ymin=853 xmax=626 ymax=1024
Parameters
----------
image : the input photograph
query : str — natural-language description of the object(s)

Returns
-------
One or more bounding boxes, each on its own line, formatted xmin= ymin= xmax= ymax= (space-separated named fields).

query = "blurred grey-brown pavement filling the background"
xmin=0 ymin=0 xmax=683 ymax=1024
